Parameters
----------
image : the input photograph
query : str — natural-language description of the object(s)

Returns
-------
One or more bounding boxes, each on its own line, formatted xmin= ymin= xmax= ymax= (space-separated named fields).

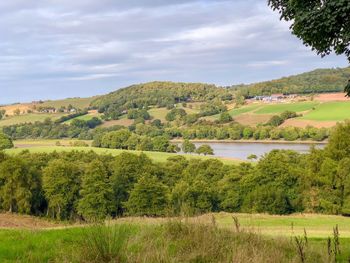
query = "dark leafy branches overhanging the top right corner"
xmin=269 ymin=0 xmax=350 ymax=96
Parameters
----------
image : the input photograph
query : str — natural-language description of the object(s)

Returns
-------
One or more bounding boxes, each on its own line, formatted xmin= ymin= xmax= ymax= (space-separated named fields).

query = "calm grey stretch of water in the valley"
xmin=180 ymin=142 xmax=325 ymax=160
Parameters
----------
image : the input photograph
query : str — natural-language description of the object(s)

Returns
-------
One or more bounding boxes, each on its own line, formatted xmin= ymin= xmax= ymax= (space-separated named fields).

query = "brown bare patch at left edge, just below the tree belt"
xmin=0 ymin=213 xmax=60 ymax=229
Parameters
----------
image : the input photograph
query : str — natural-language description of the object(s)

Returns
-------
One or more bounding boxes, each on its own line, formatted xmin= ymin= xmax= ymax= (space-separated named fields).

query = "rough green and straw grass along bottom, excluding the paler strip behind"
xmin=0 ymin=221 xmax=347 ymax=263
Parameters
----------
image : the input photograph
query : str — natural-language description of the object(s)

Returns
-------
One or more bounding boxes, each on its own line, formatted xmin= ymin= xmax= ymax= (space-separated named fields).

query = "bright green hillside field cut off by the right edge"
xmin=302 ymin=102 xmax=350 ymax=121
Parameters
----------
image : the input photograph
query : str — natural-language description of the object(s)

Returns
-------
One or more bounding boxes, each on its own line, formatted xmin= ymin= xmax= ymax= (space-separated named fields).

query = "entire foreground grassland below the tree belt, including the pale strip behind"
xmin=0 ymin=213 xmax=350 ymax=263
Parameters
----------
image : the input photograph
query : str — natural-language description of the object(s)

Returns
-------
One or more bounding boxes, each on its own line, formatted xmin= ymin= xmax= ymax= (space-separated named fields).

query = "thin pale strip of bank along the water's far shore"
xmin=171 ymin=139 xmax=328 ymax=145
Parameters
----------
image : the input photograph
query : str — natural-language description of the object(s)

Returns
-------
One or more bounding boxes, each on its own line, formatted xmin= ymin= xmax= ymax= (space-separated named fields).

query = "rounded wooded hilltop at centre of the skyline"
xmin=91 ymin=81 xmax=233 ymax=118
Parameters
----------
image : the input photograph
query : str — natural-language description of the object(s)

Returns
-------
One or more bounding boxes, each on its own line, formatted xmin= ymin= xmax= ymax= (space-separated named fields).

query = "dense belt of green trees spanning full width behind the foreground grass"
xmin=0 ymin=122 xmax=350 ymax=221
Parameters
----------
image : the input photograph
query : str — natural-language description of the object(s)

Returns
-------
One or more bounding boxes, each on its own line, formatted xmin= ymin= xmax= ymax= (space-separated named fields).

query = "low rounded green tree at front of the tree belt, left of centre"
xmin=126 ymin=174 xmax=169 ymax=216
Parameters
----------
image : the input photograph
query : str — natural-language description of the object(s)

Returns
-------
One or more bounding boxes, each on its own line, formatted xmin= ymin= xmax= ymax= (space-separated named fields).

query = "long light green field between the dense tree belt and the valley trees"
xmin=6 ymin=140 xmax=242 ymax=164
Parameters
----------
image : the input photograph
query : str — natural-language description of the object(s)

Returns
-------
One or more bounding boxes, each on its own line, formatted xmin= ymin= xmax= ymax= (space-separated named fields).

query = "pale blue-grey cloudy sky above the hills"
xmin=0 ymin=0 xmax=348 ymax=104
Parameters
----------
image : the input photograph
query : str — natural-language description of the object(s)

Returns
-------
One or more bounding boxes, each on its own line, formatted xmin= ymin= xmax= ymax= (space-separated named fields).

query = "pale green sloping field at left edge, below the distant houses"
xmin=0 ymin=113 xmax=66 ymax=127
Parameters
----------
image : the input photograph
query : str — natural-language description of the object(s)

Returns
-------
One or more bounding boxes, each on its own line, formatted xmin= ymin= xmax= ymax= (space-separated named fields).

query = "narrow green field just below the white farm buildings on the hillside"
xmin=254 ymin=101 xmax=318 ymax=114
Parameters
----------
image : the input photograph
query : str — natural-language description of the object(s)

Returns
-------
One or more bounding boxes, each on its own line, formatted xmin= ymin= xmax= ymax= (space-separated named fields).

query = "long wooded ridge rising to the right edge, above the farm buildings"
xmin=231 ymin=67 xmax=350 ymax=97
